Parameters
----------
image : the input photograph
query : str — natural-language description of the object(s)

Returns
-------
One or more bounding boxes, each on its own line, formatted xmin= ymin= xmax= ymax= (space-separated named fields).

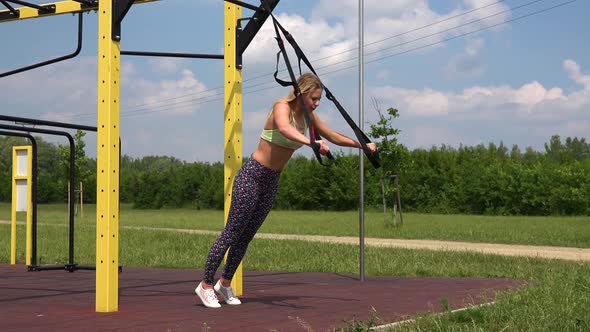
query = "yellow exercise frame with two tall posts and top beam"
xmin=0 ymin=0 xmax=247 ymax=312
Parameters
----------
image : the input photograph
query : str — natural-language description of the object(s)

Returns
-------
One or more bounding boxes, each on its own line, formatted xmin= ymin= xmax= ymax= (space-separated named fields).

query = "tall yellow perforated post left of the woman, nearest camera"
xmin=96 ymin=1 xmax=121 ymax=312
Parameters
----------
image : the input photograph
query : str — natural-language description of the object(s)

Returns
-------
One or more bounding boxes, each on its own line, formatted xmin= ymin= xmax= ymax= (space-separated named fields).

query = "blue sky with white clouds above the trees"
xmin=0 ymin=0 xmax=590 ymax=162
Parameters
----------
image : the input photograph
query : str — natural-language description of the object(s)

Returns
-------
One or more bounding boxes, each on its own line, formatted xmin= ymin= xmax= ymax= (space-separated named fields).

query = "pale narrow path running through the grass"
xmin=124 ymin=226 xmax=590 ymax=261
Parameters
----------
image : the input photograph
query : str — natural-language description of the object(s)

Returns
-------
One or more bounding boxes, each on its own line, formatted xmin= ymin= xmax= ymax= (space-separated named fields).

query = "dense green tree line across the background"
xmin=0 ymin=119 xmax=590 ymax=215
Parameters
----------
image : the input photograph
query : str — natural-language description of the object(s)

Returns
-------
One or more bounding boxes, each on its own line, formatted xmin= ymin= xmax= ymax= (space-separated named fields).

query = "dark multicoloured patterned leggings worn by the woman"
xmin=203 ymin=158 xmax=281 ymax=284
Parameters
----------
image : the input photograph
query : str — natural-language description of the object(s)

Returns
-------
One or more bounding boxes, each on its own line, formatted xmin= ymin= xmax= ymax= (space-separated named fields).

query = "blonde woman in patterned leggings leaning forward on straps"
xmin=195 ymin=73 xmax=376 ymax=308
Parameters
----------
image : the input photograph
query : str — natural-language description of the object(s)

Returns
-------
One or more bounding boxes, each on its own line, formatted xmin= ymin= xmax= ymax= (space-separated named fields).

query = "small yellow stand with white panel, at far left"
xmin=10 ymin=146 xmax=33 ymax=265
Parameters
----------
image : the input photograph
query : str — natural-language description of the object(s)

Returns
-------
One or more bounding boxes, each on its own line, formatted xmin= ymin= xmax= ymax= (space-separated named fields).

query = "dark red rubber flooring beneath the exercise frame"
xmin=0 ymin=264 xmax=524 ymax=332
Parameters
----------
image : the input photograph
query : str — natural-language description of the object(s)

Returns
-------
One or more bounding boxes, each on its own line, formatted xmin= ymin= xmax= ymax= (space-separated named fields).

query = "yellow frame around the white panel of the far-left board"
xmin=10 ymin=146 xmax=33 ymax=265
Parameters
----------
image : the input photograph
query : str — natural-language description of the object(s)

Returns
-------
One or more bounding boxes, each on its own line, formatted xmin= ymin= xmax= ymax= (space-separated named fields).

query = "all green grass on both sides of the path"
xmin=0 ymin=202 xmax=590 ymax=331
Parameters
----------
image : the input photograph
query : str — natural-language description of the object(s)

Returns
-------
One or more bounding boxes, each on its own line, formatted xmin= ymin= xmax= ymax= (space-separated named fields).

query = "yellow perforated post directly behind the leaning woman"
xmin=223 ymin=2 xmax=243 ymax=296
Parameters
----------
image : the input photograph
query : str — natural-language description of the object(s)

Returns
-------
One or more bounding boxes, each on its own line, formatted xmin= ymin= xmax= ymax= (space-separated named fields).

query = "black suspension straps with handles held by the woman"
xmin=261 ymin=0 xmax=381 ymax=168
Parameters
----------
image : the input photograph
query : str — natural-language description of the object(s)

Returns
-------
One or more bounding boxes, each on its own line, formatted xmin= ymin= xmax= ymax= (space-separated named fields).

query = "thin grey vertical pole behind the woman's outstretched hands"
xmin=359 ymin=0 xmax=365 ymax=281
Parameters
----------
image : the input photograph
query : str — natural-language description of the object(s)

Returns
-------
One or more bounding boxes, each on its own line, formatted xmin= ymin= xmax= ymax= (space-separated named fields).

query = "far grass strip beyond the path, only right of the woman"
xmin=268 ymin=211 xmax=590 ymax=248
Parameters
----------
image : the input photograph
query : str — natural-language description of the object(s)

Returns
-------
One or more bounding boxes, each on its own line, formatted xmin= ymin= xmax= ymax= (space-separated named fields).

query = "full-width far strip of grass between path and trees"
xmin=0 ymin=203 xmax=590 ymax=248
